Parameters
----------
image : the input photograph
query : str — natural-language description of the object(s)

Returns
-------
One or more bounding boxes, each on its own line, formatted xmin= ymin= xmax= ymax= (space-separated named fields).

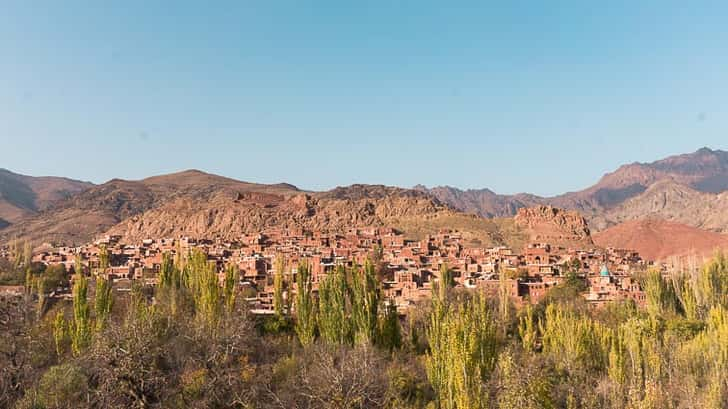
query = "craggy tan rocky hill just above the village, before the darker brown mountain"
xmin=108 ymin=185 xmax=450 ymax=240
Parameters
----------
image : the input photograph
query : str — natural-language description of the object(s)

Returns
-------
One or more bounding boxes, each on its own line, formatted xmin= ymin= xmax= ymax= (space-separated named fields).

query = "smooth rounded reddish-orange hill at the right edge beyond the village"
xmin=594 ymin=219 xmax=728 ymax=260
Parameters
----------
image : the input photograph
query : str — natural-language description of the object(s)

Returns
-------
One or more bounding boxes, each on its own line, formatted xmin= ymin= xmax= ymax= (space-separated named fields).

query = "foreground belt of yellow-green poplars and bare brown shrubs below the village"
xmin=0 ymin=252 xmax=728 ymax=409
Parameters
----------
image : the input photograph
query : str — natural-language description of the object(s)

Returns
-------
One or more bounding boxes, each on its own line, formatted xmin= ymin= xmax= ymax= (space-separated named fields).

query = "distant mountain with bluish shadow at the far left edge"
xmin=0 ymin=169 xmax=93 ymax=223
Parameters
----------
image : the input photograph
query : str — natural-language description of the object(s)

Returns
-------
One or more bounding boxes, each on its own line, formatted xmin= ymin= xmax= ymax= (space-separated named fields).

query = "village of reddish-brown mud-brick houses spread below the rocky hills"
xmin=0 ymin=228 xmax=649 ymax=314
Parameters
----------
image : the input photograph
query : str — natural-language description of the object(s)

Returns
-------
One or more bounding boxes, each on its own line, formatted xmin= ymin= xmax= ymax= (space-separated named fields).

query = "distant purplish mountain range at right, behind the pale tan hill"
xmin=415 ymin=148 xmax=728 ymax=222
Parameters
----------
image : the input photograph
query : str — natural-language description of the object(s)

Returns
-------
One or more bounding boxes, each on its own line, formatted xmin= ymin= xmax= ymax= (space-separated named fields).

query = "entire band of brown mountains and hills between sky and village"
xmin=0 ymin=148 xmax=728 ymax=257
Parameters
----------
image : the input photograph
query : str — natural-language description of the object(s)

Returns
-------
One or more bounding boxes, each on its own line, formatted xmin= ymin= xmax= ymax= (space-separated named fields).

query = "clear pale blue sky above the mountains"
xmin=0 ymin=0 xmax=728 ymax=194
